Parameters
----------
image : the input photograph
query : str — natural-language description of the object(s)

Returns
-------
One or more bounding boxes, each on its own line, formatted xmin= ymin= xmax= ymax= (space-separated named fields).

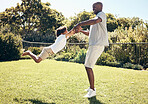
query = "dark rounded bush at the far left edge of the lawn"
xmin=0 ymin=33 xmax=22 ymax=61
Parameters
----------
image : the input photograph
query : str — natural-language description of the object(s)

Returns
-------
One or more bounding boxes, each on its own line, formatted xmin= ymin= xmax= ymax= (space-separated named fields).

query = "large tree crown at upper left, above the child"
xmin=0 ymin=0 xmax=65 ymax=42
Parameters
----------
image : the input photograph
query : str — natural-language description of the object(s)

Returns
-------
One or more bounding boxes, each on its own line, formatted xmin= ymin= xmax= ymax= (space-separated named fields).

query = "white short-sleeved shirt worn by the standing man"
xmin=89 ymin=12 xmax=109 ymax=46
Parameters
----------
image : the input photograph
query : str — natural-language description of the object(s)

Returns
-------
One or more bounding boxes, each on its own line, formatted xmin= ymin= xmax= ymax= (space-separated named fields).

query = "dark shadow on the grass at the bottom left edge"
xmin=13 ymin=98 xmax=56 ymax=104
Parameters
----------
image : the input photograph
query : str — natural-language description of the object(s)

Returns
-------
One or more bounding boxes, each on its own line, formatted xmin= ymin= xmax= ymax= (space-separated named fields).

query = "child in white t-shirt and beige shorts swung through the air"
xmin=22 ymin=26 xmax=75 ymax=63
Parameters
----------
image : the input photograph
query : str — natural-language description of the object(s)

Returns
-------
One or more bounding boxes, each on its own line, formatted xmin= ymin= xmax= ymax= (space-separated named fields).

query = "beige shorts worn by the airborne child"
xmin=39 ymin=46 xmax=54 ymax=60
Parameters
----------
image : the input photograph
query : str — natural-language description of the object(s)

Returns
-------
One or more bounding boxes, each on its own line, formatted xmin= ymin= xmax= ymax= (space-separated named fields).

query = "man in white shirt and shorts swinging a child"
xmin=74 ymin=2 xmax=109 ymax=98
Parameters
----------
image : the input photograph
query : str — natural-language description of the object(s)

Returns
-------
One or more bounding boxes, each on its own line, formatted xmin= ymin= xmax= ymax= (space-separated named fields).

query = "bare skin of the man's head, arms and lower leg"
xmin=74 ymin=3 xmax=102 ymax=90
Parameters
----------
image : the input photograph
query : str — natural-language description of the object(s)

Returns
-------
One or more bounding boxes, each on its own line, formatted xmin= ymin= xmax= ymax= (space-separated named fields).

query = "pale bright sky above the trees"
xmin=0 ymin=0 xmax=148 ymax=21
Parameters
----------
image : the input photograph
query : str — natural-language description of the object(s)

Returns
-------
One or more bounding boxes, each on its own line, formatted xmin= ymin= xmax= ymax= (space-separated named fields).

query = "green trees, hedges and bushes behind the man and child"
xmin=0 ymin=0 xmax=148 ymax=69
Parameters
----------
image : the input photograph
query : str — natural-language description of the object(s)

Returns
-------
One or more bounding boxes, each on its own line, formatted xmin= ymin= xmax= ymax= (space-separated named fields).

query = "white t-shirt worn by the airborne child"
xmin=50 ymin=34 xmax=66 ymax=54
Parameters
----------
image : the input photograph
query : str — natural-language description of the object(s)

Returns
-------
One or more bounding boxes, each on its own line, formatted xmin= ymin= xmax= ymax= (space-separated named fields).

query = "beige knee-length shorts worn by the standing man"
xmin=84 ymin=45 xmax=104 ymax=68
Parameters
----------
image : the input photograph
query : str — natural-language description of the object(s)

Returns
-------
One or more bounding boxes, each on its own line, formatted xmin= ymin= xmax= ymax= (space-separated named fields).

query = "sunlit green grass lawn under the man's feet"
xmin=0 ymin=60 xmax=148 ymax=104
